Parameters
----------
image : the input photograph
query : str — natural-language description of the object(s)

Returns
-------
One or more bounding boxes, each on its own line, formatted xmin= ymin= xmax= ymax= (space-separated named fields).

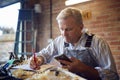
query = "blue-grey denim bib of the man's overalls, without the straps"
xmin=65 ymin=48 xmax=98 ymax=68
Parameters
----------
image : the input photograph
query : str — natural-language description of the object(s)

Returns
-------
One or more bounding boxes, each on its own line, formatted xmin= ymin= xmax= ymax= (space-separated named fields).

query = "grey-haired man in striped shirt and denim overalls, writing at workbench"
xmin=30 ymin=7 xmax=118 ymax=80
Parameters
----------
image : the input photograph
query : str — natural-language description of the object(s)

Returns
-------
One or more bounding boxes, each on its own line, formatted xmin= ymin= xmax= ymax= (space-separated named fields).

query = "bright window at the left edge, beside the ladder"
xmin=0 ymin=3 xmax=20 ymax=63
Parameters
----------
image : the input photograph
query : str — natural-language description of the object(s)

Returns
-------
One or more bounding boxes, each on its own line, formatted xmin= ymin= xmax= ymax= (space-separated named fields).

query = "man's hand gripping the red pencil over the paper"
xmin=30 ymin=56 xmax=44 ymax=69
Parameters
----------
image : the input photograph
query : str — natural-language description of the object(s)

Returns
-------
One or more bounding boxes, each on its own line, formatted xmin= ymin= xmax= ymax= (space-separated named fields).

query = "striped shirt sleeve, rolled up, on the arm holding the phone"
xmin=91 ymin=36 xmax=119 ymax=80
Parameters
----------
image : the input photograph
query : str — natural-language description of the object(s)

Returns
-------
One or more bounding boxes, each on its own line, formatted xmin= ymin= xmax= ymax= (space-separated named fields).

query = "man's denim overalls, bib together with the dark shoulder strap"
xmin=64 ymin=35 xmax=98 ymax=77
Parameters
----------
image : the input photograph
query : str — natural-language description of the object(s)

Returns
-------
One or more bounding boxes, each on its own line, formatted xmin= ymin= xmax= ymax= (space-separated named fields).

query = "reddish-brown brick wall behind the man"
xmin=37 ymin=0 xmax=120 ymax=74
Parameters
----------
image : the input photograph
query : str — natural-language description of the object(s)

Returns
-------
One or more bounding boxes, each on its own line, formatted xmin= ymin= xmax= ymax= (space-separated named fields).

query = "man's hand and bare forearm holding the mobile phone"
xmin=59 ymin=57 xmax=100 ymax=80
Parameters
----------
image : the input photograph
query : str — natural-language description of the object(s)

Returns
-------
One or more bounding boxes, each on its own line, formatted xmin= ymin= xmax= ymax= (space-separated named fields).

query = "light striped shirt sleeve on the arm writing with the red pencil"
xmin=37 ymin=36 xmax=64 ymax=63
